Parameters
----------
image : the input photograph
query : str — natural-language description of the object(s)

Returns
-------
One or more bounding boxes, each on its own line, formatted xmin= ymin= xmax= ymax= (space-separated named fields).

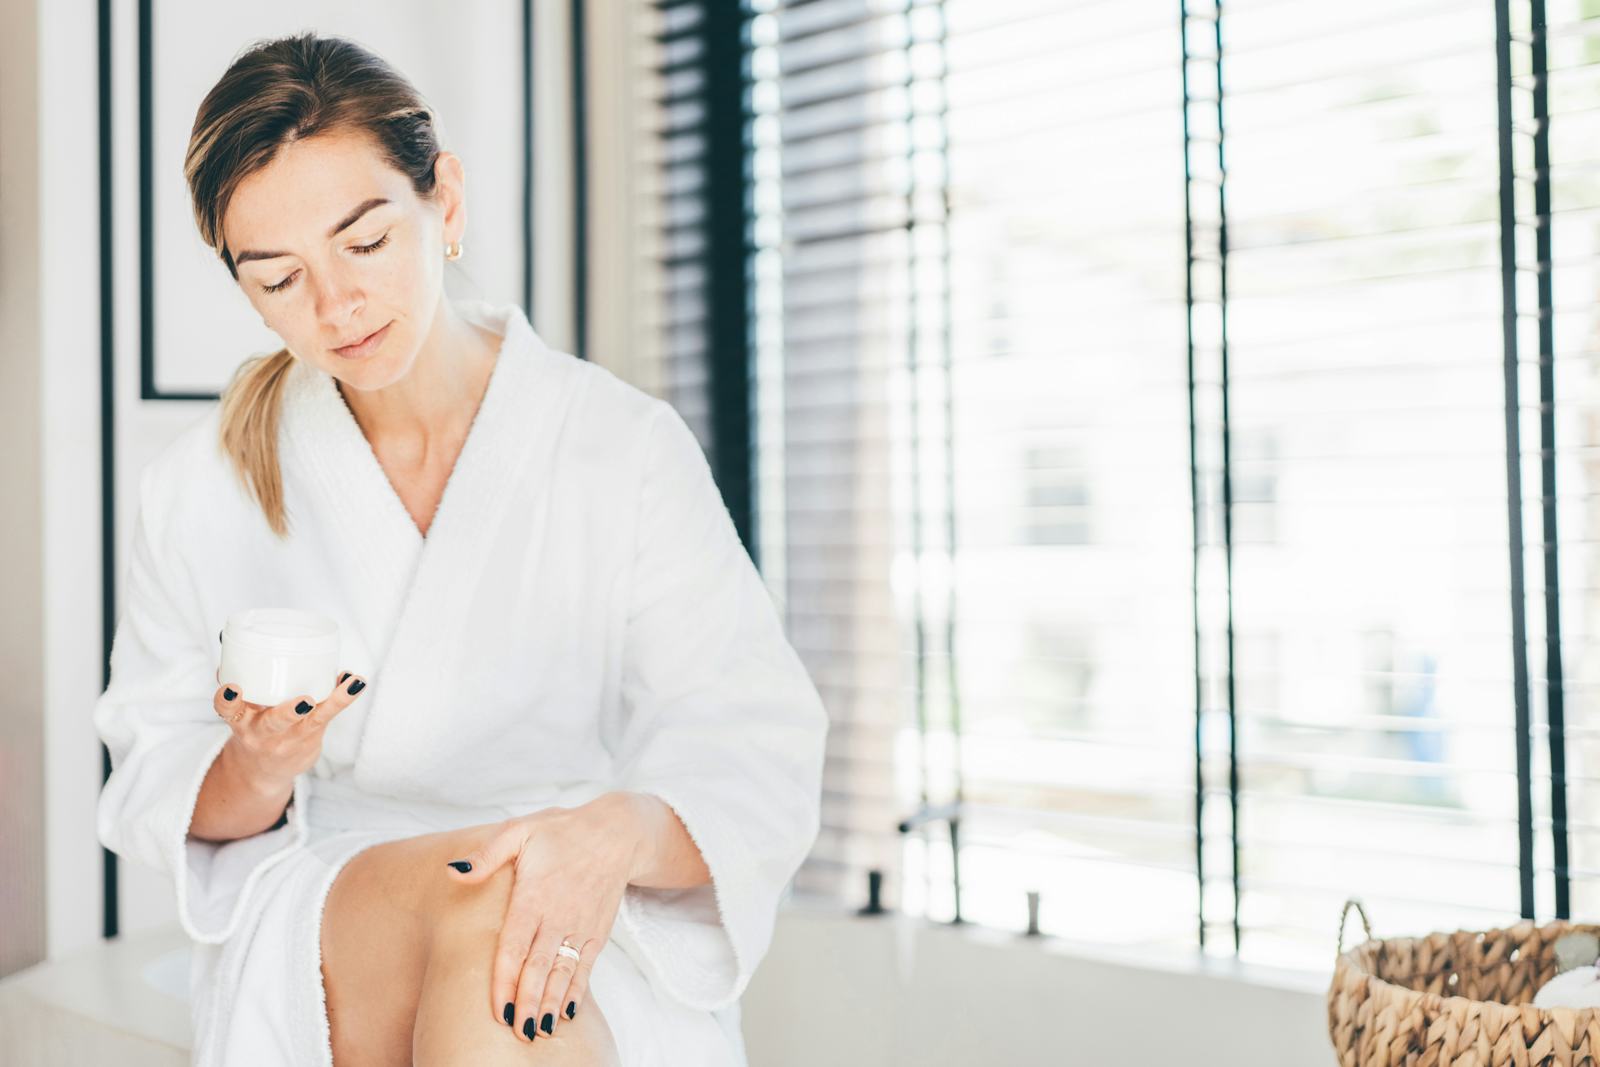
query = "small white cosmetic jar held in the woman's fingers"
xmin=219 ymin=608 xmax=339 ymax=707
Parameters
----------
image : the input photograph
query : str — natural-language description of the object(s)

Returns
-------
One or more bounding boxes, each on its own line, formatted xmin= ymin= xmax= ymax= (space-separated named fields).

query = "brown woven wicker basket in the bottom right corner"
xmin=1328 ymin=901 xmax=1600 ymax=1067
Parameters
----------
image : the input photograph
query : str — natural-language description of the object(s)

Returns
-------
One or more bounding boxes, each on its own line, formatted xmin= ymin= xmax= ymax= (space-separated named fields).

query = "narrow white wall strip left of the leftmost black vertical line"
xmin=31 ymin=2 xmax=104 ymax=953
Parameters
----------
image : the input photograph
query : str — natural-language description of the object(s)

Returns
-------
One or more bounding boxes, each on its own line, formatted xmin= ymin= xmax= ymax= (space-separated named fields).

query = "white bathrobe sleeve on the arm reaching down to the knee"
xmin=616 ymin=402 xmax=827 ymax=1011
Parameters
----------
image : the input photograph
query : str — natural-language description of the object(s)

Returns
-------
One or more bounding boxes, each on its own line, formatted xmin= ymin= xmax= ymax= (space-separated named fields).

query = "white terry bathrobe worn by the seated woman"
xmin=94 ymin=301 xmax=827 ymax=1067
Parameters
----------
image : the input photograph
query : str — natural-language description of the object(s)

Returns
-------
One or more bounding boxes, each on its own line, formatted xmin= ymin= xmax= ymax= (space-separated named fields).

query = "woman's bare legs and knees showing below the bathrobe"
xmin=322 ymin=824 xmax=618 ymax=1067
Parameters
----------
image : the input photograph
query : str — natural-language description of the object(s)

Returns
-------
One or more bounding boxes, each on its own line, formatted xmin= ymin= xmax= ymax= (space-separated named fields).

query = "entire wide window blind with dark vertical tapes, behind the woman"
xmin=620 ymin=0 xmax=1600 ymax=969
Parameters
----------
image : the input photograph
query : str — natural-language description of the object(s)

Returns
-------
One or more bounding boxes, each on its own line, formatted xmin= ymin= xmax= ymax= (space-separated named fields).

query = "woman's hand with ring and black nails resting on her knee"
xmin=450 ymin=793 xmax=637 ymax=1038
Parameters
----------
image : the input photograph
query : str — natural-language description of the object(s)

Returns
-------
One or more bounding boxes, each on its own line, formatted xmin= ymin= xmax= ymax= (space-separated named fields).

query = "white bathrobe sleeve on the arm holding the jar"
xmin=94 ymin=466 xmax=307 ymax=944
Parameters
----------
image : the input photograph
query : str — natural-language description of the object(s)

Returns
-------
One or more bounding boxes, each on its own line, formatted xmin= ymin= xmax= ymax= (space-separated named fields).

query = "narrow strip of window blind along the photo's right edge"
xmin=1536 ymin=0 xmax=1600 ymax=920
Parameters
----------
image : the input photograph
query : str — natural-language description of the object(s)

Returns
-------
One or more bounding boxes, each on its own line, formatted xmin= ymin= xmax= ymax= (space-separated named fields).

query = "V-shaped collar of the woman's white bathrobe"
xmin=278 ymin=301 xmax=578 ymax=783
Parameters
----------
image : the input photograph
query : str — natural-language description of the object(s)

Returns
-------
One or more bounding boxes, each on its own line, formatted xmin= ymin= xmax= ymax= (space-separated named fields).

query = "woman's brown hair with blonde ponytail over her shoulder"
xmin=184 ymin=32 xmax=440 ymax=537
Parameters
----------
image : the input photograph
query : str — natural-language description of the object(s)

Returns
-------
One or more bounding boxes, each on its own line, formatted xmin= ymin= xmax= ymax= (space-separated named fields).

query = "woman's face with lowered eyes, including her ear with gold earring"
xmin=222 ymin=133 xmax=466 ymax=390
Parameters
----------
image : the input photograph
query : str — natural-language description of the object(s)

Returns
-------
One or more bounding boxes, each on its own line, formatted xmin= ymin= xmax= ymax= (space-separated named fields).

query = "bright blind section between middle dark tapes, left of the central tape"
xmin=926 ymin=0 xmax=1197 ymax=945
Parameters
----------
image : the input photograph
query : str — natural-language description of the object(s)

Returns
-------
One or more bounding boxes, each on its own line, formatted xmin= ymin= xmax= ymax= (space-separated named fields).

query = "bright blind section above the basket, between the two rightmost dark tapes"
xmin=1221 ymin=0 xmax=1518 ymax=965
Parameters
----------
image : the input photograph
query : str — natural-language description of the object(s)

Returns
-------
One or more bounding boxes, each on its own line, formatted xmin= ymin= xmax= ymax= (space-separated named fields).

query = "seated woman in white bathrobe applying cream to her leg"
xmin=94 ymin=34 xmax=827 ymax=1067
